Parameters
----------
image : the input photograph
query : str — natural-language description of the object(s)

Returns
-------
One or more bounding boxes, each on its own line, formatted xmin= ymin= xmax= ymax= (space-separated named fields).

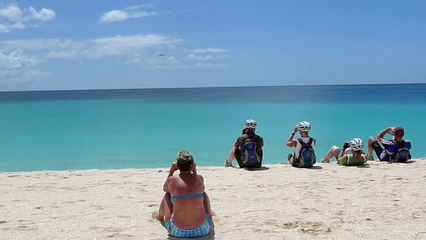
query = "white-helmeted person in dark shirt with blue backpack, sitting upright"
xmin=225 ymin=119 xmax=263 ymax=168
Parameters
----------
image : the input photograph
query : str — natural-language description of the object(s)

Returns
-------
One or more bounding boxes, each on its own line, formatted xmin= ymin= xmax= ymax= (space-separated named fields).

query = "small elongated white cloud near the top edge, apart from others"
xmin=99 ymin=5 xmax=158 ymax=23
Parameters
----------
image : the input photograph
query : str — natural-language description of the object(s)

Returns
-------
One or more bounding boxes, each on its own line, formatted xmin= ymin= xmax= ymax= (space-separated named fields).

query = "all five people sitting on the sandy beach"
xmin=152 ymin=119 xmax=411 ymax=238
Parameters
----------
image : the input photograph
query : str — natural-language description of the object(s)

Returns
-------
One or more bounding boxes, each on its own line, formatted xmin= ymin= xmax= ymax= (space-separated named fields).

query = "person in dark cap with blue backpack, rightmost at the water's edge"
xmin=368 ymin=127 xmax=411 ymax=162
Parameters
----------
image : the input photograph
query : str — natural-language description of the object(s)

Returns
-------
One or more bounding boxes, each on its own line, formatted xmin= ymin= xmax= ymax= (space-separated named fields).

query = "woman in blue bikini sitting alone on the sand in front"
xmin=152 ymin=151 xmax=214 ymax=238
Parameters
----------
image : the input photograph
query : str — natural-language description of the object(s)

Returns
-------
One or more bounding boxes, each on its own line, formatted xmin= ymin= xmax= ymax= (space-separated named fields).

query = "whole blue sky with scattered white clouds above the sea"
xmin=0 ymin=0 xmax=426 ymax=91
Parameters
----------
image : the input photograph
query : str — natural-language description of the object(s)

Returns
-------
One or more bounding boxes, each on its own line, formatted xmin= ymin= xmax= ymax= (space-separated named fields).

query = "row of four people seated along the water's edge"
xmin=225 ymin=119 xmax=411 ymax=168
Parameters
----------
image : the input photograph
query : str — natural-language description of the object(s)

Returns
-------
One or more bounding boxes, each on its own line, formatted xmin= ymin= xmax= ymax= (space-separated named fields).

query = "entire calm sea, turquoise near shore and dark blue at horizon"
xmin=0 ymin=84 xmax=426 ymax=172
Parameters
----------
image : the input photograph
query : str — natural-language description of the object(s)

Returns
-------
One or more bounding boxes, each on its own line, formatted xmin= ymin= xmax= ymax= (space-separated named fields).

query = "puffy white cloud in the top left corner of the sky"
xmin=0 ymin=5 xmax=56 ymax=33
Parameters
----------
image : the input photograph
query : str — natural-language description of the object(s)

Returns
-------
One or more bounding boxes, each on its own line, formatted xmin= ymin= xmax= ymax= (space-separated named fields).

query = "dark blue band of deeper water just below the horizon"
xmin=0 ymin=83 xmax=426 ymax=103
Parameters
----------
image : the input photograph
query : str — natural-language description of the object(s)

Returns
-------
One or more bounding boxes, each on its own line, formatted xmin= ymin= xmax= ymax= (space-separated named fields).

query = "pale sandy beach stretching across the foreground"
xmin=0 ymin=160 xmax=426 ymax=239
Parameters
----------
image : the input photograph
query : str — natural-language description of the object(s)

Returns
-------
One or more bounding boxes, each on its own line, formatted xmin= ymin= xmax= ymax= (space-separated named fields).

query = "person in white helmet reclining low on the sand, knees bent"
xmin=321 ymin=138 xmax=367 ymax=166
